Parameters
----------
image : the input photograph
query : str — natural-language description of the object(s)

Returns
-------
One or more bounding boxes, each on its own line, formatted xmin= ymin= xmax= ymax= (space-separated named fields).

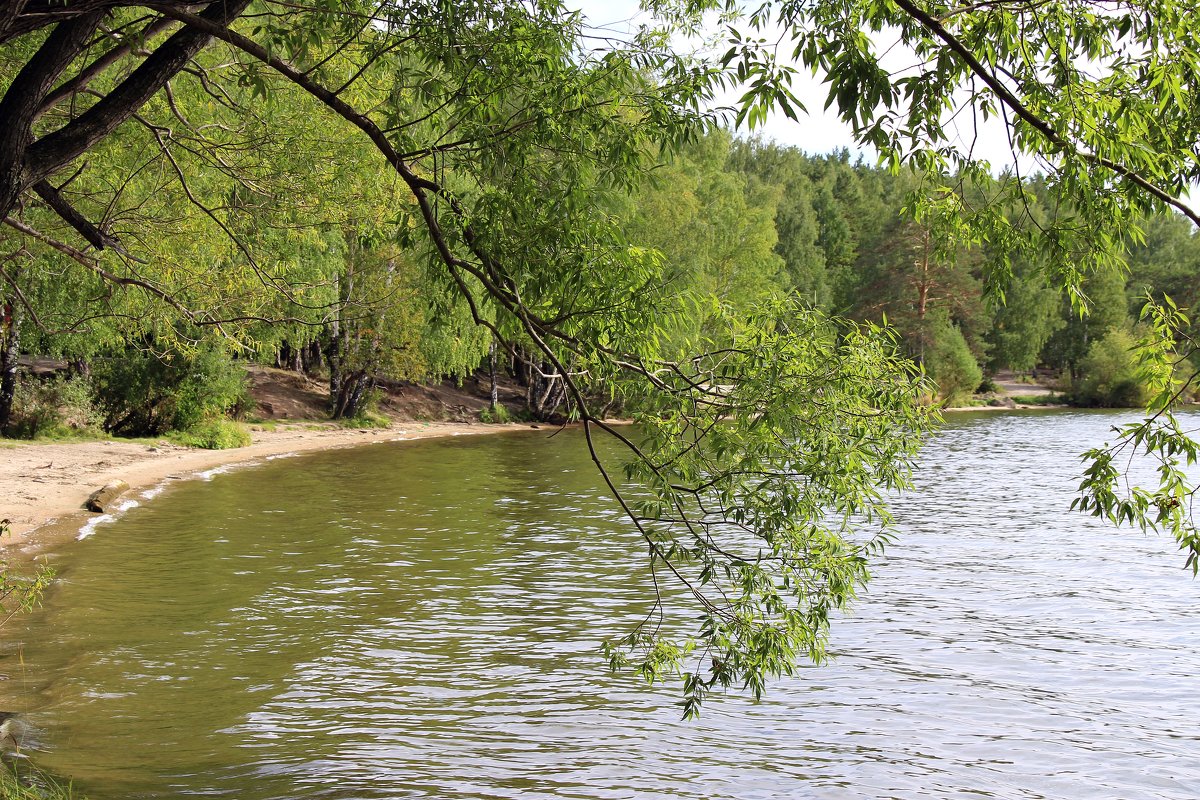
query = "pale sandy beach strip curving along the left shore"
xmin=0 ymin=421 xmax=528 ymax=555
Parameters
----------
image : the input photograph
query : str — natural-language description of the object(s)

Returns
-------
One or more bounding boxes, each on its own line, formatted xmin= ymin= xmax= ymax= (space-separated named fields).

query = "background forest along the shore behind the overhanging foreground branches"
xmin=0 ymin=133 xmax=1200 ymax=446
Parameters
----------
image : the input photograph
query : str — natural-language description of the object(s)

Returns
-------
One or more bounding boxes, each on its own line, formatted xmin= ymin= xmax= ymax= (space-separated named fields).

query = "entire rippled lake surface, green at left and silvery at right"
xmin=4 ymin=414 xmax=1200 ymax=800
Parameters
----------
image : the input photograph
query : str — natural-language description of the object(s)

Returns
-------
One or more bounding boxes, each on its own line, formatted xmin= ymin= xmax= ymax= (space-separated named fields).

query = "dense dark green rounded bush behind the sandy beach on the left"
xmin=92 ymin=347 xmax=250 ymax=437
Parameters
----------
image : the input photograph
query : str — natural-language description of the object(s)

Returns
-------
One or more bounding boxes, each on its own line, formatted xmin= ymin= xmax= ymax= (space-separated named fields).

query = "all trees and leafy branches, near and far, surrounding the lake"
xmin=0 ymin=0 xmax=1200 ymax=715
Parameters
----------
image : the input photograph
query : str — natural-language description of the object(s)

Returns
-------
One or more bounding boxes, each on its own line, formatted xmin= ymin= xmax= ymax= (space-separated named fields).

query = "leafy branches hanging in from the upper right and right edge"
xmin=710 ymin=0 xmax=1200 ymax=571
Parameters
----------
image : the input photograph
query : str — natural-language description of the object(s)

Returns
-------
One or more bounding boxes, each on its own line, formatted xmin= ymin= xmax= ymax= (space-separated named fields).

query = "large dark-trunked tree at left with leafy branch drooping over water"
xmin=0 ymin=0 xmax=928 ymax=712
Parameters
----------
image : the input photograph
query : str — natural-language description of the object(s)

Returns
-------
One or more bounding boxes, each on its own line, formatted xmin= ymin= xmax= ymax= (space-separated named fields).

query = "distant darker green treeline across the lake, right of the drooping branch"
xmin=715 ymin=136 xmax=1200 ymax=405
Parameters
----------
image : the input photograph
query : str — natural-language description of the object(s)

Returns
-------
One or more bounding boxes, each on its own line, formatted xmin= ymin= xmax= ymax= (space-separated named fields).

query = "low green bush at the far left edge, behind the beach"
xmin=10 ymin=375 xmax=102 ymax=439
